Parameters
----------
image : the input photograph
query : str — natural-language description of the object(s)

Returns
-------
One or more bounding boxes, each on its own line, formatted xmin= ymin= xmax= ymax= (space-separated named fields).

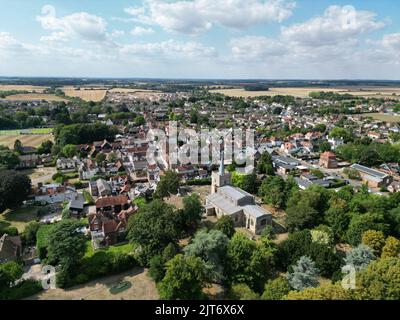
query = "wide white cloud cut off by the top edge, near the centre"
xmin=125 ymin=0 xmax=295 ymax=34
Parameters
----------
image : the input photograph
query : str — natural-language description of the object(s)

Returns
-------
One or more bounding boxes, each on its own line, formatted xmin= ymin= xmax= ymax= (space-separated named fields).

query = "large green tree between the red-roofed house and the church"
xmin=127 ymin=200 xmax=180 ymax=265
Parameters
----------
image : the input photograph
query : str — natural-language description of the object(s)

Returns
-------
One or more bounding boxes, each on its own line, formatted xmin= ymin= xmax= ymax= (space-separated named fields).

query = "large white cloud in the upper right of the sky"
xmin=282 ymin=6 xmax=385 ymax=47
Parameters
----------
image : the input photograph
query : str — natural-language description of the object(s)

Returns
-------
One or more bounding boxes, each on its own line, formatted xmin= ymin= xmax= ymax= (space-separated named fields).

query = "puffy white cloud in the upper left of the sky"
xmin=36 ymin=6 xmax=107 ymax=41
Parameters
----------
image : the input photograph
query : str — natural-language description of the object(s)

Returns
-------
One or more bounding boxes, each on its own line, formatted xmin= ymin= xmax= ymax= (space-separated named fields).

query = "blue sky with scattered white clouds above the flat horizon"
xmin=0 ymin=0 xmax=400 ymax=80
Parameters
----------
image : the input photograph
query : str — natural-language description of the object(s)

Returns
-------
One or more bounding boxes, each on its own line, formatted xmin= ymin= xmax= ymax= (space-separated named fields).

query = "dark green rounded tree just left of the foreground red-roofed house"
xmin=47 ymin=220 xmax=86 ymax=273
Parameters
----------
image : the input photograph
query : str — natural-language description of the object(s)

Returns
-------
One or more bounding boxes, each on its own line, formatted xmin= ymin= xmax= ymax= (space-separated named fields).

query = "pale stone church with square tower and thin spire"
xmin=206 ymin=151 xmax=272 ymax=234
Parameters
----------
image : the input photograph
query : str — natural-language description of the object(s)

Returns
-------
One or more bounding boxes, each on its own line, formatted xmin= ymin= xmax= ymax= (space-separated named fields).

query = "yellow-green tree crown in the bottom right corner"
xmin=357 ymin=258 xmax=400 ymax=300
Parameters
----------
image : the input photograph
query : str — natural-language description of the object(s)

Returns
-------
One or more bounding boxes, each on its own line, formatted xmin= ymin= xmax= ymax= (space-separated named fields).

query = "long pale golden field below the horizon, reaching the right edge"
xmin=210 ymin=87 xmax=400 ymax=99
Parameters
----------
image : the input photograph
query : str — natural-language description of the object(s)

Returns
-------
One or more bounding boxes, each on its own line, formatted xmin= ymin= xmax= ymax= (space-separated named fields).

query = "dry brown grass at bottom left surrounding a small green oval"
xmin=27 ymin=268 xmax=159 ymax=300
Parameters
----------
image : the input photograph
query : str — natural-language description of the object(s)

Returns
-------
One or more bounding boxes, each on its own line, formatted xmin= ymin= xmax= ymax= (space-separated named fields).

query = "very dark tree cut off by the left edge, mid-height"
xmin=0 ymin=170 xmax=31 ymax=212
